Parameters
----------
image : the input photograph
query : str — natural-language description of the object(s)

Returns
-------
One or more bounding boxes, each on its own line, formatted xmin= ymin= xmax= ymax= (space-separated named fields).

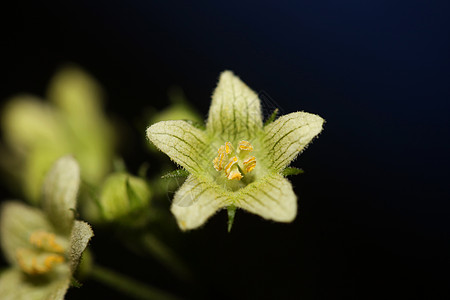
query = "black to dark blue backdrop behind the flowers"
xmin=0 ymin=0 xmax=450 ymax=299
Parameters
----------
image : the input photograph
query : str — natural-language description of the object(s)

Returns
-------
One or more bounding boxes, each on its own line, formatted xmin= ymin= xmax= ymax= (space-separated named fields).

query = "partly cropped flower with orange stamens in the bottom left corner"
xmin=0 ymin=156 xmax=93 ymax=300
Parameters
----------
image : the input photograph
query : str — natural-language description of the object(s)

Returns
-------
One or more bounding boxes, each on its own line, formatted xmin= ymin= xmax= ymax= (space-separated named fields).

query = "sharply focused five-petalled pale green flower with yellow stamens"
xmin=147 ymin=71 xmax=324 ymax=230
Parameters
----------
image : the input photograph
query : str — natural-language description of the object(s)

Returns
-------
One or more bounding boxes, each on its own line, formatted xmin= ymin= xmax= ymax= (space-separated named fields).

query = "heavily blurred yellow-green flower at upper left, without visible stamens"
xmin=0 ymin=66 xmax=114 ymax=204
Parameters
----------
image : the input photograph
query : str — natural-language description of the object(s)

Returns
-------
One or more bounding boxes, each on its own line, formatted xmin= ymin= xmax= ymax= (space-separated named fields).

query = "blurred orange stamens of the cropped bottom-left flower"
xmin=16 ymin=231 xmax=64 ymax=275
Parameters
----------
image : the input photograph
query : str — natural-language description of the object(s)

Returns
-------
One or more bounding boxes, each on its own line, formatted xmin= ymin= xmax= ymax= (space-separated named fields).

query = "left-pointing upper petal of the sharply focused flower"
xmin=147 ymin=120 xmax=214 ymax=174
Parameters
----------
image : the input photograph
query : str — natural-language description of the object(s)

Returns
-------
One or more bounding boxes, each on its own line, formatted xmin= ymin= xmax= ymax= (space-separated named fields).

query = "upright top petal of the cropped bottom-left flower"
xmin=42 ymin=156 xmax=80 ymax=234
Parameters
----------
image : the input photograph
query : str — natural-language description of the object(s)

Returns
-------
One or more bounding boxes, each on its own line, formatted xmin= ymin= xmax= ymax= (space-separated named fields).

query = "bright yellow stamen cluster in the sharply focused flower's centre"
xmin=213 ymin=141 xmax=256 ymax=180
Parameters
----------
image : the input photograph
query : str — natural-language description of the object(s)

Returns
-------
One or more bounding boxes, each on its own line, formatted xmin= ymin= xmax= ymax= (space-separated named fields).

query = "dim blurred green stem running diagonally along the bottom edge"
xmin=90 ymin=265 xmax=180 ymax=300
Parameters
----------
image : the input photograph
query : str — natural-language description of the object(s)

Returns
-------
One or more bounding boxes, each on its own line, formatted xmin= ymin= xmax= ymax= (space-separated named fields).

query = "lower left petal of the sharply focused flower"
xmin=171 ymin=175 xmax=229 ymax=230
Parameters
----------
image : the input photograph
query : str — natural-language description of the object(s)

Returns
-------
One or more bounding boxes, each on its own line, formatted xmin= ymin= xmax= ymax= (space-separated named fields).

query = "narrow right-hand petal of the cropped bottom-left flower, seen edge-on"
xmin=68 ymin=221 xmax=94 ymax=273
